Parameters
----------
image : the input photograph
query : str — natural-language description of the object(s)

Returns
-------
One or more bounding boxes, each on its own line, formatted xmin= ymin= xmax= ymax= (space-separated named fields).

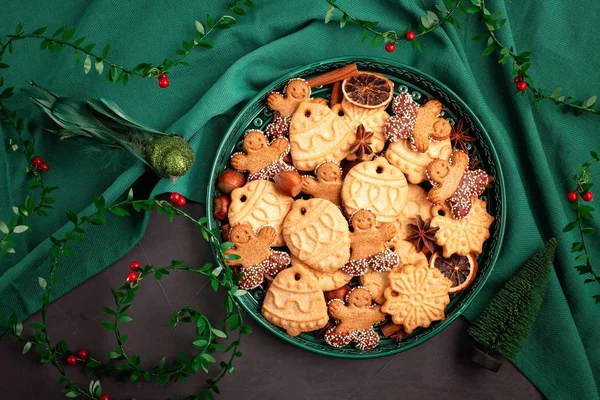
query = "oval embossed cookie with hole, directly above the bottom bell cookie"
xmin=283 ymin=198 xmax=350 ymax=272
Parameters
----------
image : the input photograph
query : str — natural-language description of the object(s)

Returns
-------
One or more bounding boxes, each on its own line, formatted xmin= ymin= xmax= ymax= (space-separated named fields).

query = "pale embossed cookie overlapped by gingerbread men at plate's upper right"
xmin=385 ymin=139 xmax=452 ymax=184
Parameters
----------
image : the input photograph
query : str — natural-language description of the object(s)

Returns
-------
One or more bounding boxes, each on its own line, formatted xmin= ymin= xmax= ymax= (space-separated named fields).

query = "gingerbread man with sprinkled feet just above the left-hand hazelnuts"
xmin=231 ymin=130 xmax=293 ymax=181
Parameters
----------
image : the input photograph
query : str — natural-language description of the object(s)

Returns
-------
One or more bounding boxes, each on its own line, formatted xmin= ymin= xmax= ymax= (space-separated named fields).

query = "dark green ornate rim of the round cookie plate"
xmin=206 ymin=56 xmax=506 ymax=359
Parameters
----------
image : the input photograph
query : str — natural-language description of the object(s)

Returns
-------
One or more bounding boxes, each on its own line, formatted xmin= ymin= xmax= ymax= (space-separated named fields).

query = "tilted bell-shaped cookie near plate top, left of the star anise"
xmin=290 ymin=102 xmax=356 ymax=171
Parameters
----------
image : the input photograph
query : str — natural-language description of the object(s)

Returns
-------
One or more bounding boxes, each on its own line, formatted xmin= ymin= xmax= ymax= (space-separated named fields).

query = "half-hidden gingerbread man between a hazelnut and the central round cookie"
xmin=302 ymin=161 xmax=342 ymax=206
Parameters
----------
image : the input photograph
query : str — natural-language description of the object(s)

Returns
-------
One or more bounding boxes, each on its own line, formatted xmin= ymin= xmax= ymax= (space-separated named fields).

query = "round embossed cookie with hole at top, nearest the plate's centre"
xmin=342 ymin=157 xmax=408 ymax=222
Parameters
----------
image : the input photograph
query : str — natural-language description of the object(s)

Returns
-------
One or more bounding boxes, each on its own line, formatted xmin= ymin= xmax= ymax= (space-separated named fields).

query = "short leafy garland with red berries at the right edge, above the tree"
xmin=563 ymin=150 xmax=600 ymax=304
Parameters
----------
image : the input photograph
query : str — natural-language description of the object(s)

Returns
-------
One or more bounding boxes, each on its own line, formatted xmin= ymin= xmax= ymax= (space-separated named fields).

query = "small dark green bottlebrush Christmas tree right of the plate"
xmin=469 ymin=238 xmax=556 ymax=372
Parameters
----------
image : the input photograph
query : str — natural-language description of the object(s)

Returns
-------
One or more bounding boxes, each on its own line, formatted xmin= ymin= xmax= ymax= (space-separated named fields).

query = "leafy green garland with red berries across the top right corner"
xmin=325 ymin=0 xmax=600 ymax=115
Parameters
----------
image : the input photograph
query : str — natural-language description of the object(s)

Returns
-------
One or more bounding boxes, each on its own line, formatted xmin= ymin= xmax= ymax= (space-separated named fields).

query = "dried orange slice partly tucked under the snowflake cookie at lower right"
xmin=429 ymin=252 xmax=477 ymax=294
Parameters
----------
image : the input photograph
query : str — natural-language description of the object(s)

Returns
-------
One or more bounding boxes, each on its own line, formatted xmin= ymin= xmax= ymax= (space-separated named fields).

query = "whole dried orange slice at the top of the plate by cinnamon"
xmin=342 ymin=72 xmax=394 ymax=108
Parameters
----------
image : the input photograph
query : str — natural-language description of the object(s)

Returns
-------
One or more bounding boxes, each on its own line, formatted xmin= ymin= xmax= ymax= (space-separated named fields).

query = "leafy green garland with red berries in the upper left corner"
xmin=0 ymin=0 xmax=254 ymax=258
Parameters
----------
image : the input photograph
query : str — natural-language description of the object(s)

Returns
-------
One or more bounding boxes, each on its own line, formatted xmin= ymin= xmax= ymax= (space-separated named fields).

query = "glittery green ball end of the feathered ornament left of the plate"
xmin=145 ymin=135 xmax=194 ymax=179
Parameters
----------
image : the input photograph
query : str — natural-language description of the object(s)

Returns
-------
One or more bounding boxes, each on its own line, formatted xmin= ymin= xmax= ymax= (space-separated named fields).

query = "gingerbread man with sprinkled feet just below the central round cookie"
xmin=342 ymin=210 xmax=399 ymax=276
